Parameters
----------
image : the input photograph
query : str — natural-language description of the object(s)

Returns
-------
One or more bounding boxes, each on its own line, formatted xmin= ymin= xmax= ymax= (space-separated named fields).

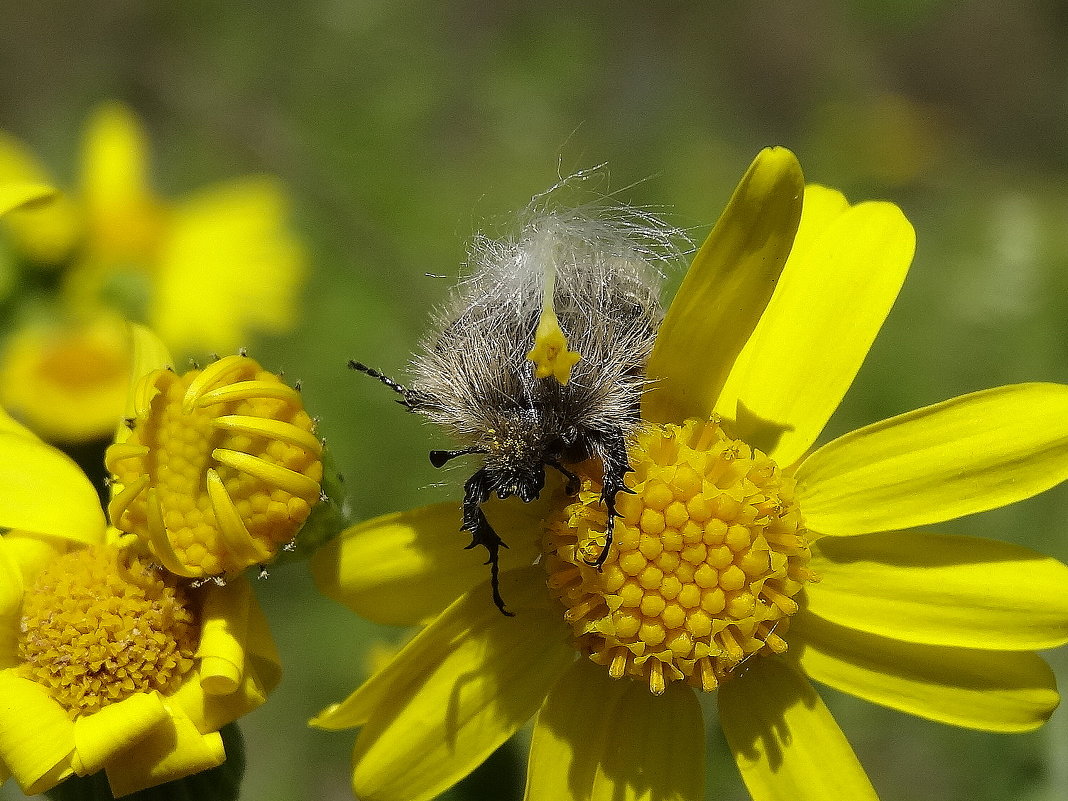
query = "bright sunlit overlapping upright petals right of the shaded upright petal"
xmin=716 ymin=186 xmax=916 ymax=465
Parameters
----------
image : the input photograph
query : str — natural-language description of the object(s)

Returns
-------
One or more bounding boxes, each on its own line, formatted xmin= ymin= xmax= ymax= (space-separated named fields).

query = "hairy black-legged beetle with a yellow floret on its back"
xmin=349 ymin=194 xmax=678 ymax=614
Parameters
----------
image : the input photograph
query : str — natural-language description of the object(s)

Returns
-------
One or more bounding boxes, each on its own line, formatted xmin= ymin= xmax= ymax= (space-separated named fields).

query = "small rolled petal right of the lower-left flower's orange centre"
xmin=197 ymin=577 xmax=251 ymax=695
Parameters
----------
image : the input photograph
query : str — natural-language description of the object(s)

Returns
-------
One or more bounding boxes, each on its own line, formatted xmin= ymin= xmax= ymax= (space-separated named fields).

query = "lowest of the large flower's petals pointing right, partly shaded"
xmin=789 ymin=612 xmax=1059 ymax=732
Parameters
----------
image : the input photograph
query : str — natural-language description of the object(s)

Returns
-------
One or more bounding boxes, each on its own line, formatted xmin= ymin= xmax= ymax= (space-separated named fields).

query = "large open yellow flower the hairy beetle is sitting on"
xmin=313 ymin=148 xmax=1068 ymax=801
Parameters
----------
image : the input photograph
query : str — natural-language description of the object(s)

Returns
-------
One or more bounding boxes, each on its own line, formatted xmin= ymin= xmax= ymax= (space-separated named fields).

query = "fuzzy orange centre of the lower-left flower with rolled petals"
xmin=18 ymin=546 xmax=198 ymax=719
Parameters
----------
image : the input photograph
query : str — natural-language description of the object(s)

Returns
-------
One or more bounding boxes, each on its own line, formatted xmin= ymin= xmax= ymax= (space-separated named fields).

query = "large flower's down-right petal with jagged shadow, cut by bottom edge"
xmin=719 ymin=658 xmax=878 ymax=801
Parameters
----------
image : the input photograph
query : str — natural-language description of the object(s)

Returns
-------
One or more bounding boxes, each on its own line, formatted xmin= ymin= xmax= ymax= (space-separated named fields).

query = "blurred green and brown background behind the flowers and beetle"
xmin=0 ymin=0 xmax=1068 ymax=801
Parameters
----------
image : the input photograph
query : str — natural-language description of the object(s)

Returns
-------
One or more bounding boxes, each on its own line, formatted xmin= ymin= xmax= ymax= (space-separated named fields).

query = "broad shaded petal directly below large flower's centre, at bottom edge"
xmin=524 ymin=659 xmax=705 ymax=801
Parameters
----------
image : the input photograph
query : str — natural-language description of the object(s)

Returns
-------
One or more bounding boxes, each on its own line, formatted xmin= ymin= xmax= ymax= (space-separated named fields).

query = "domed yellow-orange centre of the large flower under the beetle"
xmin=545 ymin=420 xmax=814 ymax=695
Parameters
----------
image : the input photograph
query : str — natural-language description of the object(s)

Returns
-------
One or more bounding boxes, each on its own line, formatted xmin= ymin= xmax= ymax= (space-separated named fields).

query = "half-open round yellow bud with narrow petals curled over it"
xmin=107 ymin=356 xmax=323 ymax=577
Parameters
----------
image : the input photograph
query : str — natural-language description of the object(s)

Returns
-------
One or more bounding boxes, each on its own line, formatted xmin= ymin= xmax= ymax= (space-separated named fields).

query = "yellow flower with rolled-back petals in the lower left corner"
xmin=0 ymin=401 xmax=280 ymax=796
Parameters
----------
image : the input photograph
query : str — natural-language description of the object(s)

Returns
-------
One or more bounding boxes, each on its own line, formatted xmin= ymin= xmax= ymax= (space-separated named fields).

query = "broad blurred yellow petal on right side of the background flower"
xmin=150 ymin=178 xmax=307 ymax=351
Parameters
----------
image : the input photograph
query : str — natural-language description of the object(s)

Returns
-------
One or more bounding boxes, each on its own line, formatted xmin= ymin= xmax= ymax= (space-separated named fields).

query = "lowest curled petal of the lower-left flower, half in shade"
xmin=106 ymin=708 xmax=226 ymax=798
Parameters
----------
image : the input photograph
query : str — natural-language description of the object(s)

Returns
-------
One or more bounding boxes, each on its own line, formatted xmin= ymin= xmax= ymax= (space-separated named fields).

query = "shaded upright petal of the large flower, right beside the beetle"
xmin=642 ymin=147 xmax=804 ymax=423
